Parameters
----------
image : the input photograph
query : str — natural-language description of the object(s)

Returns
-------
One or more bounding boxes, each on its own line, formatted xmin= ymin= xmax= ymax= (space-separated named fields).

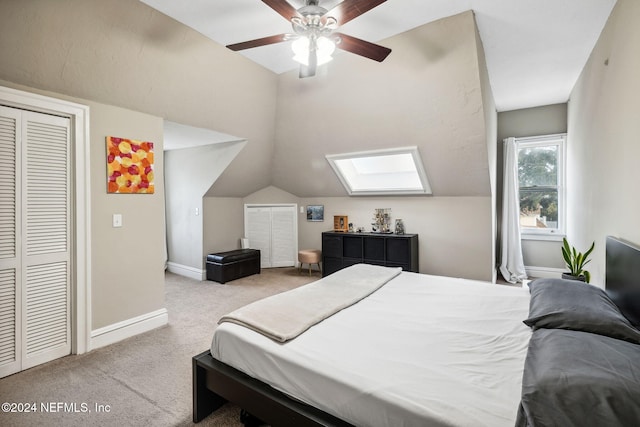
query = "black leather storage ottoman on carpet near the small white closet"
xmin=207 ymin=249 xmax=260 ymax=283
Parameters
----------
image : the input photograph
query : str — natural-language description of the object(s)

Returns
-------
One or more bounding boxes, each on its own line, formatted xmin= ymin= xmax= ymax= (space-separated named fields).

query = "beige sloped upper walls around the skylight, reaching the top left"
xmin=0 ymin=0 xmax=490 ymax=201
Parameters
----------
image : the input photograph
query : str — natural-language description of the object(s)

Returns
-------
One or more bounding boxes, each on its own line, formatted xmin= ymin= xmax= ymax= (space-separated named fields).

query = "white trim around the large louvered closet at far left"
xmin=0 ymin=86 xmax=91 ymax=354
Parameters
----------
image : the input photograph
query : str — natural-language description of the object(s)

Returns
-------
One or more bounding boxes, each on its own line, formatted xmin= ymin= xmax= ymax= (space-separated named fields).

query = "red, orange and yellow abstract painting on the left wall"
xmin=107 ymin=136 xmax=154 ymax=194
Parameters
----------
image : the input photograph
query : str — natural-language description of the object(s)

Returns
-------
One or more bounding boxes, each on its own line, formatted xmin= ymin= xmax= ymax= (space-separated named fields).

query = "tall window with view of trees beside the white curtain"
xmin=516 ymin=134 xmax=566 ymax=238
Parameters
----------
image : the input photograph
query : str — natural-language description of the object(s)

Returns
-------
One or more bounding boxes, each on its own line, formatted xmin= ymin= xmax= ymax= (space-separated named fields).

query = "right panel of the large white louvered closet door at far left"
xmin=22 ymin=112 xmax=71 ymax=369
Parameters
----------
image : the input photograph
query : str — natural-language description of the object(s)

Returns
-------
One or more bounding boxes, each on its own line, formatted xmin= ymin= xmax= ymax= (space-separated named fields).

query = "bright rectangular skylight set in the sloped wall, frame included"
xmin=326 ymin=147 xmax=431 ymax=196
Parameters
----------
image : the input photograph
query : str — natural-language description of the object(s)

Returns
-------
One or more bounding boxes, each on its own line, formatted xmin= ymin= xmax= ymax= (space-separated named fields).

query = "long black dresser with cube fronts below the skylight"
xmin=322 ymin=231 xmax=419 ymax=276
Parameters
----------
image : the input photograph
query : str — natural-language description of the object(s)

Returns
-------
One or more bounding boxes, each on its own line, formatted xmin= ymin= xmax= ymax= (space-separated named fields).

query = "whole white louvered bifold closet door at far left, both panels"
xmin=0 ymin=107 xmax=71 ymax=377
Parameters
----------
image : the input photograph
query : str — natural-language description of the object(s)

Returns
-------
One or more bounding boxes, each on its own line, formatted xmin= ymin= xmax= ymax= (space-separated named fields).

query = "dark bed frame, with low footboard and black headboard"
xmin=192 ymin=237 xmax=640 ymax=427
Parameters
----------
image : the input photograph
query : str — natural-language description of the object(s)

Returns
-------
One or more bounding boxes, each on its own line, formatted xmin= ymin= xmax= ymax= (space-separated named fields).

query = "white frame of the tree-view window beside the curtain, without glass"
xmin=515 ymin=133 xmax=567 ymax=240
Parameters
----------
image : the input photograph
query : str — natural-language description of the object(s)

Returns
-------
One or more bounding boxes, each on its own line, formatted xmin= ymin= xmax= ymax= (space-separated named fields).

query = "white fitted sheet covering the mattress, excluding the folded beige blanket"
xmin=211 ymin=272 xmax=531 ymax=427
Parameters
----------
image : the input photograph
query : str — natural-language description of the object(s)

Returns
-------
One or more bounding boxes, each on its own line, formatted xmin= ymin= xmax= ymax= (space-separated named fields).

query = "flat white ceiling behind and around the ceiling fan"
xmin=141 ymin=0 xmax=616 ymax=111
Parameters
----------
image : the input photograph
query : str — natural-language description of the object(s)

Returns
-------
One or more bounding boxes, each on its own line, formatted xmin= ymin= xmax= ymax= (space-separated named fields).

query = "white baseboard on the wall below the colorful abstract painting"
xmin=90 ymin=308 xmax=169 ymax=349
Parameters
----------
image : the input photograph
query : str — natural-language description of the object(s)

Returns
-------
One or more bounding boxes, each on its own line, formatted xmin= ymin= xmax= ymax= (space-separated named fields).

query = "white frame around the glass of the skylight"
xmin=325 ymin=147 xmax=431 ymax=196
